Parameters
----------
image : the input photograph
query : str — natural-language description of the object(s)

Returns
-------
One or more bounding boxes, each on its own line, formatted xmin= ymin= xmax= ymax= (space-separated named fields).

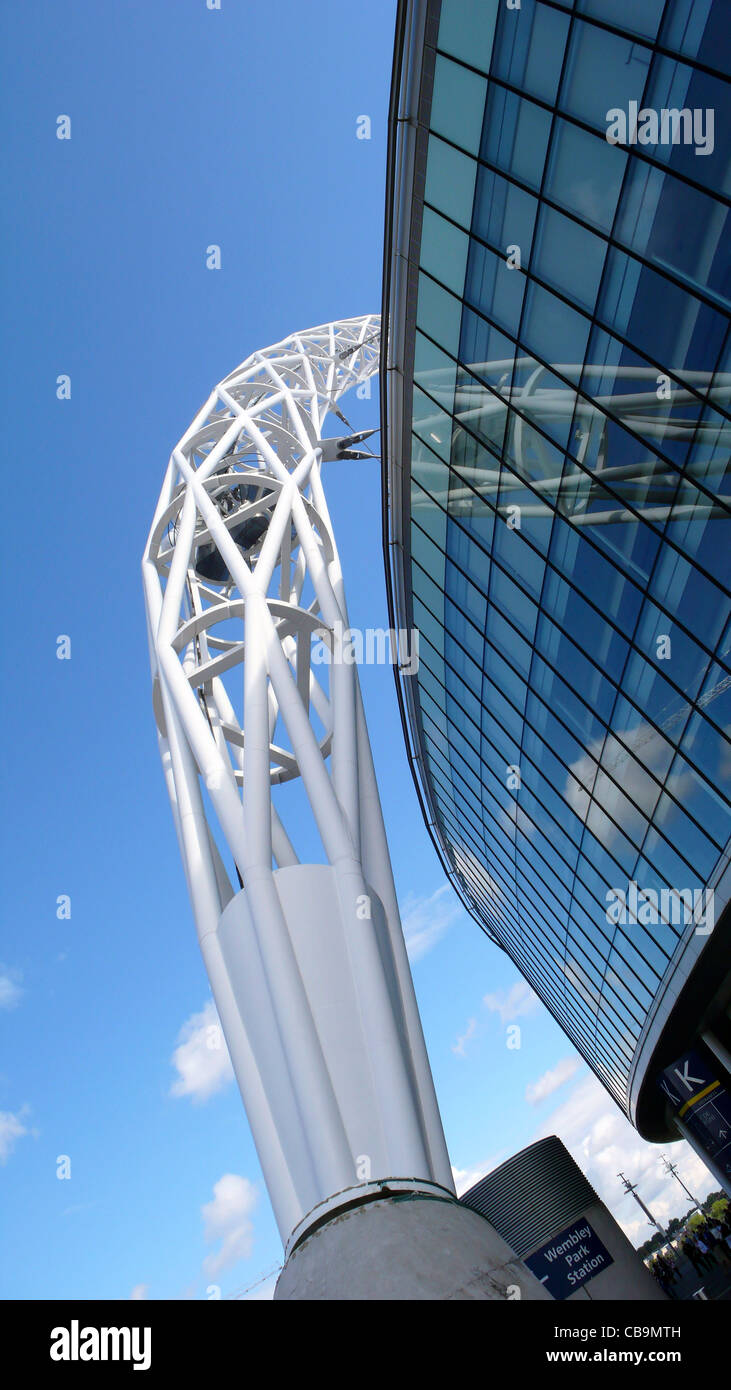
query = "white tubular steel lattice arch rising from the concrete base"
xmin=143 ymin=316 xmax=453 ymax=1250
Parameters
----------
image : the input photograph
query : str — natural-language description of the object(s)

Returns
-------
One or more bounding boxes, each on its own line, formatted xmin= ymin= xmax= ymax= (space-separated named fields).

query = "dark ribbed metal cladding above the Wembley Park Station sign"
xmin=460 ymin=1134 xmax=600 ymax=1259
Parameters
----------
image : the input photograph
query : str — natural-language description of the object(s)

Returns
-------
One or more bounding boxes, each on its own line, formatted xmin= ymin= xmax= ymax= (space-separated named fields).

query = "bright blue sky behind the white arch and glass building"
xmin=0 ymin=0 xmax=713 ymax=1298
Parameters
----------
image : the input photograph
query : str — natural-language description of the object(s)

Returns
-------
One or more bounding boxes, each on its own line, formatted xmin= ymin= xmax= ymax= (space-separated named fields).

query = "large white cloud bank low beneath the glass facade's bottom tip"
xmin=534 ymin=1076 xmax=718 ymax=1245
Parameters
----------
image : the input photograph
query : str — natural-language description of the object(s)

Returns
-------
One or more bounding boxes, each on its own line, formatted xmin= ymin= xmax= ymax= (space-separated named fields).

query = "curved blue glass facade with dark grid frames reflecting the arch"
xmin=389 ymin=0 xmax=731 ymax=1115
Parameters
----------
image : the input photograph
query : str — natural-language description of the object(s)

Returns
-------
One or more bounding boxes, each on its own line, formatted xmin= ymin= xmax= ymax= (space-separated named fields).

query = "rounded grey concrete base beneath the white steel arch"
xmin=274 ymin=1195 xmax=550 ymax=1302
